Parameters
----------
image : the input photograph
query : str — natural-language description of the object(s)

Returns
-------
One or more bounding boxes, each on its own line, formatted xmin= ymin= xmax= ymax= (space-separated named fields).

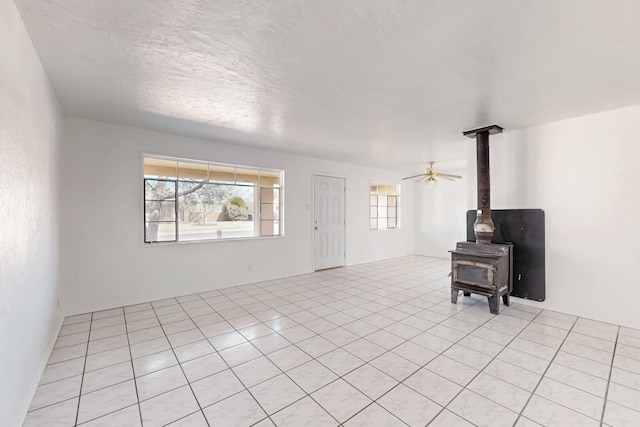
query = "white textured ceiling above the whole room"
xmin=15 ymin=0 xmax=640 ymax=173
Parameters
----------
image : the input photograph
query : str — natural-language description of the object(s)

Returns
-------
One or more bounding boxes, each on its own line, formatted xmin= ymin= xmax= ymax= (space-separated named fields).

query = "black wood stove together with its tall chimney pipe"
xmin=449 ymin=125 xmax=513 ymax=314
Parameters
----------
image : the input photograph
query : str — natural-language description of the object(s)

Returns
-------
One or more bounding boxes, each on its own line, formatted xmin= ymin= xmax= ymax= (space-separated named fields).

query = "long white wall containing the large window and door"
xmin=61 ymin=118 xmax=414 ymax=314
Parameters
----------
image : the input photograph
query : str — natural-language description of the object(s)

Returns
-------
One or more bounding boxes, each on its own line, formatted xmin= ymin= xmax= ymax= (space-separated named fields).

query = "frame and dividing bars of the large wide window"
xmin=146 ymin=153 xmax=285 ymax=246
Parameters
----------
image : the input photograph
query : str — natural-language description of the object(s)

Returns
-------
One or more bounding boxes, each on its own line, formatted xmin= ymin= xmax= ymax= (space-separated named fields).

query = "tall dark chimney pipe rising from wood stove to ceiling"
xmin=462 ymin=125 xmax=502 ymax=243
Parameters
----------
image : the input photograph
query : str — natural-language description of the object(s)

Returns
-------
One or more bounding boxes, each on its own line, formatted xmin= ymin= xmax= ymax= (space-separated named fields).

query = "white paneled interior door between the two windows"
xmin=313 ymin=175 xmax=345 ymax=270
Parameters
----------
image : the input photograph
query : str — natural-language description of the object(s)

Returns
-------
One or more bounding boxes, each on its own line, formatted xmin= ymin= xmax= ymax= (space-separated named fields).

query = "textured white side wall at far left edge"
xmin=0 ymin=0 xmax=61 ymax=426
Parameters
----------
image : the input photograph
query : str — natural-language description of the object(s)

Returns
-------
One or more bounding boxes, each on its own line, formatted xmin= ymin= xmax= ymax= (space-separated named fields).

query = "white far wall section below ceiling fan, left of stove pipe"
xmin=412 ymin=169 xmax=469 ymax=258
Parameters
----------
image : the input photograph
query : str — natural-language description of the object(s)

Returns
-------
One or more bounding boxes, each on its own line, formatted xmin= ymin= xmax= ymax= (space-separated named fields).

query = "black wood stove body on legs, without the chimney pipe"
xmin=449 ymin=242 xmax=513 ymax=314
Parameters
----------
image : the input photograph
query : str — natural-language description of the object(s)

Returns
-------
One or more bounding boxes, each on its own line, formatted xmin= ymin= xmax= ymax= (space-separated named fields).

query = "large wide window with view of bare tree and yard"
xmin=144 ymin=156 xmax=284 ymax=243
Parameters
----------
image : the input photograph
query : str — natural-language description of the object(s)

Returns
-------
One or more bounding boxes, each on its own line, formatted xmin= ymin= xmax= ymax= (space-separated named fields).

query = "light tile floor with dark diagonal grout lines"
xmin=24 ymin=256 xmax=640 ymax=427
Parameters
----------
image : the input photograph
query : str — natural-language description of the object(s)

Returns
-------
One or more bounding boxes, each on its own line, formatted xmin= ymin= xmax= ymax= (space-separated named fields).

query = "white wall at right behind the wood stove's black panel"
xmin=468 ymin=106 xmax=640 ymax=328
